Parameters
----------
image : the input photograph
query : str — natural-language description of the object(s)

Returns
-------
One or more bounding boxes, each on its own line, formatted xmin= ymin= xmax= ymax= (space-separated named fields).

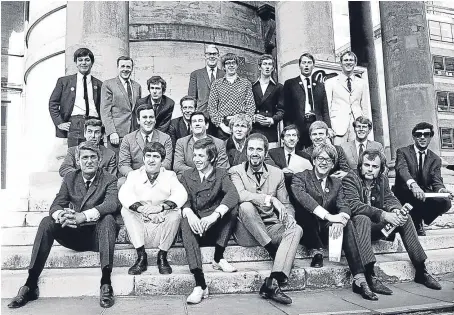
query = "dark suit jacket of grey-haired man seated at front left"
xmin=49 ymin=168 xmax=119 ymax=217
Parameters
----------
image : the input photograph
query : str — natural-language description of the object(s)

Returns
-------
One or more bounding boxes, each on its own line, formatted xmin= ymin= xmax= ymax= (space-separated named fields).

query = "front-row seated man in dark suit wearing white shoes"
xmin=181 ymin=138 xmax=238 ymax=304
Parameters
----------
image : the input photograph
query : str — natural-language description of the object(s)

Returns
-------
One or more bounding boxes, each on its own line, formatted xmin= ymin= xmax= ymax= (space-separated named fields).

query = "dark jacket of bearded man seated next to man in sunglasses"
xmin=342 ymin=171 xmax=402 ymax=223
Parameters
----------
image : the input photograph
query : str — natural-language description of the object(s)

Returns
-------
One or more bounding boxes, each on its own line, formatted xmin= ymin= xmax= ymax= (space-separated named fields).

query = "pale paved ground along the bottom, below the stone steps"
xmin=1 ymin=274 xmax=454 ymax=315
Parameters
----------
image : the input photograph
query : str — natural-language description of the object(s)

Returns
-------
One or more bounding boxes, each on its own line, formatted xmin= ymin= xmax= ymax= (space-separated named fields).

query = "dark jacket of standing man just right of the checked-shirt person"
xmin=251 ymin=80 xmax=284 ymax=142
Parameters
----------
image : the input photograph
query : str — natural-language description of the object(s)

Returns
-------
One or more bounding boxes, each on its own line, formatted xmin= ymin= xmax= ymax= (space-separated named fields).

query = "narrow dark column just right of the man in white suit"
xmin=348 ymin=1 xmax=384 ymax=144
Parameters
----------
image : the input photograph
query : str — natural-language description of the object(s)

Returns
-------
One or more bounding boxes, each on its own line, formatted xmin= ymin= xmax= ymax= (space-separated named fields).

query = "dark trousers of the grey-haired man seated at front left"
xmin=29 ymin=214 xmax=117 ymax=276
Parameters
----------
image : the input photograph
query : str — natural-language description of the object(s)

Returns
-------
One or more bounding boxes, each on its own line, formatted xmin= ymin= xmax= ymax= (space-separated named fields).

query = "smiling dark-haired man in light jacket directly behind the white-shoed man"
xmin=173 ymin=112 xmax=230 ymax=175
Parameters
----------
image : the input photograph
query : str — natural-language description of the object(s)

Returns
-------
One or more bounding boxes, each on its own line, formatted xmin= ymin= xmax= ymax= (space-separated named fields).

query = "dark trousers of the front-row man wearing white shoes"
xmin=181 ymin=206 xmax=238 ymax=270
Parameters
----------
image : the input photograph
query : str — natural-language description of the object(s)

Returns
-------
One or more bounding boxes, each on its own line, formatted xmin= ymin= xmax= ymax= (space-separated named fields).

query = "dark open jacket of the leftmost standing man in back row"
xmin=49 ymin=74 xmax=102 ymax=138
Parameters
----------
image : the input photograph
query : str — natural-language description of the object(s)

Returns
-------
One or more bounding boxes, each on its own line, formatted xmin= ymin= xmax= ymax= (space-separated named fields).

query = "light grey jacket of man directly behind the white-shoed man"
xmin=173 ymin=134 xmax=230 ymax=175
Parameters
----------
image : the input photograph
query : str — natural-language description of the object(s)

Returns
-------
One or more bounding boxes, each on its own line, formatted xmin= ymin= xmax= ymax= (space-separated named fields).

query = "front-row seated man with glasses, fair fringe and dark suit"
xmin=292 ymin=143 xmax=378 ymax=301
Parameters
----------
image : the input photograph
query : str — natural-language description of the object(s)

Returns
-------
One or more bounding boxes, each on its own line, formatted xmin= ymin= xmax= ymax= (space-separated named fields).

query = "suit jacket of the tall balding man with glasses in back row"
xmin=188 ymin=67 xmax=225 ymax=115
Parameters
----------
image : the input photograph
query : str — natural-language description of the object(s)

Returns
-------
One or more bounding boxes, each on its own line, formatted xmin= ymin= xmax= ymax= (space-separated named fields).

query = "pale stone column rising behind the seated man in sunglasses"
xmin=380 ymin=1 xmax=440 ymax=158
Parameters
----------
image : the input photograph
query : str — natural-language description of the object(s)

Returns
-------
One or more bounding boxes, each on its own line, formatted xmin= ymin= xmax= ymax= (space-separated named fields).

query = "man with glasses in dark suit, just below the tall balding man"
xmin=168 ymin=95 xmax=196 ymax=150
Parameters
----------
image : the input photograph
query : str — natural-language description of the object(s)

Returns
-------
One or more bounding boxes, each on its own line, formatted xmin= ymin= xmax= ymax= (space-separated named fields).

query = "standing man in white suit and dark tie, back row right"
xmin=325 ymin=51 xmax=370 ymax=145
